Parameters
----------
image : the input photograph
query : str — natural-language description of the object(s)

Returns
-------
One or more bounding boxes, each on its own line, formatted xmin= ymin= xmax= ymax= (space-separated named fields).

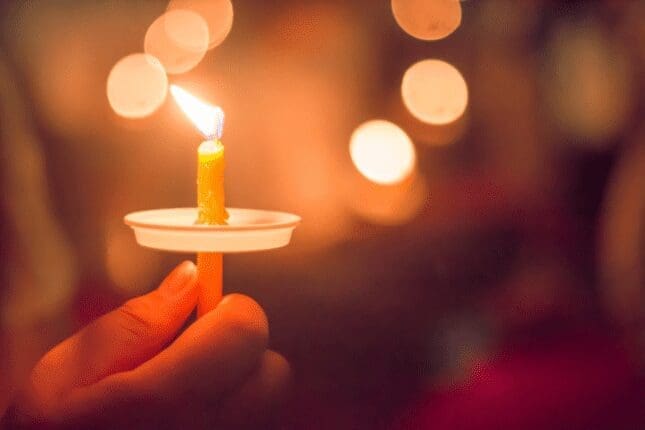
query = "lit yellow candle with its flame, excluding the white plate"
xmin=170 ymin=85 xmax=228 ymax=316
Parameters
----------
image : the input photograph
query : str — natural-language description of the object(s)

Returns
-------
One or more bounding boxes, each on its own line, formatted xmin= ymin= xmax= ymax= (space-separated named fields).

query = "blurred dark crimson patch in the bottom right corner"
xmin=395 ymin=330 xmax=645 ymax=430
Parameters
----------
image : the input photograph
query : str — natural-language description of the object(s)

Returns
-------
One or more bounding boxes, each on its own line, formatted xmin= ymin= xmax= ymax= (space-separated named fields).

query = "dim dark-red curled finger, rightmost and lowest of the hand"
xmin=218 ymin=350 xmax=291 ymax=429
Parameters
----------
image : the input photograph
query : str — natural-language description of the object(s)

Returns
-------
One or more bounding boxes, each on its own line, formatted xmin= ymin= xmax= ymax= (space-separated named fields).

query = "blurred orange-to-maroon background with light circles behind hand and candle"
xmin=0 ymin=0 xmax=645 ymax=429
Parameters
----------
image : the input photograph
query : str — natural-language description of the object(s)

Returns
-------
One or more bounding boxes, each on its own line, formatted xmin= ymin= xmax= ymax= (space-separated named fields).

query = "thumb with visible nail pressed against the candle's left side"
xmin=25 ymin=261 xmax=197 ymax=404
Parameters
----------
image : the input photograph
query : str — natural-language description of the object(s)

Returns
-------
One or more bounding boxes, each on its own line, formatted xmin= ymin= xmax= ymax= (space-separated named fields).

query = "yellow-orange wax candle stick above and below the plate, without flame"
xmin=197 ymin=140 xmax=228 ymax=316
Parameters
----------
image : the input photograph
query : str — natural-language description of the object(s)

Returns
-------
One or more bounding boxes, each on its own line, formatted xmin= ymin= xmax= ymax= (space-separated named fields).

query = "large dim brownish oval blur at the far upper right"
xmin=543 ymin=20 xmax=637 ymax=147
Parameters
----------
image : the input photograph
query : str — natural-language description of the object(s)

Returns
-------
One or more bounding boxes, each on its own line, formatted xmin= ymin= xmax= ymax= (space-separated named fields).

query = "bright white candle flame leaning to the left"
xmin=170 ymin=85 xmax=224 ymax=139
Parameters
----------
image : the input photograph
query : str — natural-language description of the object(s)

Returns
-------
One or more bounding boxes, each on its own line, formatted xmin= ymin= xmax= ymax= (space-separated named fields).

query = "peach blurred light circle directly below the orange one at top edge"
xmin=401 ymin=60 xmax=468 ymax=125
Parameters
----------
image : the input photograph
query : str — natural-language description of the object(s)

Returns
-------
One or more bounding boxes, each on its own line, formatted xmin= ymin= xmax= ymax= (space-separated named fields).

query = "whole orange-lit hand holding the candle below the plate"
xmin=0 ymin=261 xmax=289 ymax=429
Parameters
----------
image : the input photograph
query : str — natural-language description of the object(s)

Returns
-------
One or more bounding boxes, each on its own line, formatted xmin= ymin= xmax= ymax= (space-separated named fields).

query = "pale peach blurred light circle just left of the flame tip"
xmin=107 ymin=53 xmax=168 ymax=118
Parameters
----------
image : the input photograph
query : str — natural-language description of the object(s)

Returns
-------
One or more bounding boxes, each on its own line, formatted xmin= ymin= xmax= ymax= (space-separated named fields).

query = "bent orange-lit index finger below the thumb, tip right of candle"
xmin=49 ymin=294 xmax=268 ymax=425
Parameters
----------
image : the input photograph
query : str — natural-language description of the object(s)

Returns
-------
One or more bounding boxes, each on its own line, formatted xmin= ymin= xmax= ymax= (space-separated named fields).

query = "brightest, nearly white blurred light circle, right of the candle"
xmin=349 ymin=120 xmax=416 ymax=184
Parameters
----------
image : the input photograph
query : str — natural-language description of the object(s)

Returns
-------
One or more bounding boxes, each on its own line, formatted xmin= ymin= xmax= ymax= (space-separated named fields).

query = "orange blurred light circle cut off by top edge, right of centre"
xmin=392 ymin=0 xmax=461 ymax=40
